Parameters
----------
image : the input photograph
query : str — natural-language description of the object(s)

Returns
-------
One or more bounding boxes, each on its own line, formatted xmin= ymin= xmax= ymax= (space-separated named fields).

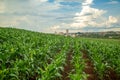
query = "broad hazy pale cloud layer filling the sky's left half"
xmin=0 ymin=0 xmax=60 ymax=31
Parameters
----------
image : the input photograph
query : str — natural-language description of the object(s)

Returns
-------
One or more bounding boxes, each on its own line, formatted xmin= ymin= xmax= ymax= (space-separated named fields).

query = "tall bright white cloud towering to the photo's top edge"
xmin=71 ymin=0 xmax=106 ymax=28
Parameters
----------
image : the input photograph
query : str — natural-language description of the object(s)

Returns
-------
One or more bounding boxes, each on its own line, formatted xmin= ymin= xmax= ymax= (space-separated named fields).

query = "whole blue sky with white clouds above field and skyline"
xmin=0 ymin=0 xmax=120 ymax=33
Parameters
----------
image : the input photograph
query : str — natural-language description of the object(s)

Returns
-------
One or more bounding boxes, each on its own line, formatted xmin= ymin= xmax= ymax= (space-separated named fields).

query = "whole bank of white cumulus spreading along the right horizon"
xmin=50 ymin=0 xmax=120 ymax=31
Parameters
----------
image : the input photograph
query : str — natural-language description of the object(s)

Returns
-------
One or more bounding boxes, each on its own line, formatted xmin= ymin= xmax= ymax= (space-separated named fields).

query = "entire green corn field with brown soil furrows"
xmin=0 ymin=28 xmax=120 ymax=80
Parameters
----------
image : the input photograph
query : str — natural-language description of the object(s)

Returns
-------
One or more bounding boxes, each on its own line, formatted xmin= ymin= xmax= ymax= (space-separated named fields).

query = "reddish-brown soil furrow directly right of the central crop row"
xmin=81 ymin=50 xmax=99 ymax=80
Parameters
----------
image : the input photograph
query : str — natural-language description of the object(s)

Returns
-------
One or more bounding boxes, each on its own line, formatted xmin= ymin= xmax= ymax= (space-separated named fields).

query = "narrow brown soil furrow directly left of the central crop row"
xmin=61 ymin=50 xmax=72 ymax=80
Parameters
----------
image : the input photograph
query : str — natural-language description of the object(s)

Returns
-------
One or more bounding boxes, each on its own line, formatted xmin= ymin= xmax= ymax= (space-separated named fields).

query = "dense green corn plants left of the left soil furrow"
xmin=0 ymin=28 xmax=68 ymax=80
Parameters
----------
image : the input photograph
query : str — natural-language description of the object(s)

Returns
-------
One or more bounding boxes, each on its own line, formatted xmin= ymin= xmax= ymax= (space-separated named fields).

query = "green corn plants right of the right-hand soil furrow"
xmin=80 ymin=40 xmax=120 ymax=80
